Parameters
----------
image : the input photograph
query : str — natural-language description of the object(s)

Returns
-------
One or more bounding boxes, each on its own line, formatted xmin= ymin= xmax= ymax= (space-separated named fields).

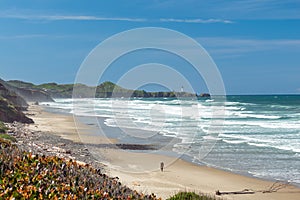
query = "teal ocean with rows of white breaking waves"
xmin=43 ymin=95 xmax=300 ymax=186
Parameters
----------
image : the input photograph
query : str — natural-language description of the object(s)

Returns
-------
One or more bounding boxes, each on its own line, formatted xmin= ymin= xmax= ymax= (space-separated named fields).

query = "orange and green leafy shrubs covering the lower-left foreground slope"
xmin=0 ymin=138 xmax=157 ymax=200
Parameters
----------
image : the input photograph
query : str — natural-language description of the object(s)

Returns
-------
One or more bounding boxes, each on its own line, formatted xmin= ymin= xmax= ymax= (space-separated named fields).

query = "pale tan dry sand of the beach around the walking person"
xmin=27 ymin=106 xmax=300 ymax=200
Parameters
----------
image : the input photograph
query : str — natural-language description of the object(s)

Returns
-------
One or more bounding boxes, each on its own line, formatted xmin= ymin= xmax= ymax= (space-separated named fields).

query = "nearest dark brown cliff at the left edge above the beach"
xmin=0 ymin=83 xmax=33 ymax=123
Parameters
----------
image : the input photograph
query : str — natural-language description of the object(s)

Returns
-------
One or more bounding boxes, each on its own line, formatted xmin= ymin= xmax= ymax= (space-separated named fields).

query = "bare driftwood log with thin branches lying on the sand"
xmin=216 ymin=181 xmax=289 ymax=195
